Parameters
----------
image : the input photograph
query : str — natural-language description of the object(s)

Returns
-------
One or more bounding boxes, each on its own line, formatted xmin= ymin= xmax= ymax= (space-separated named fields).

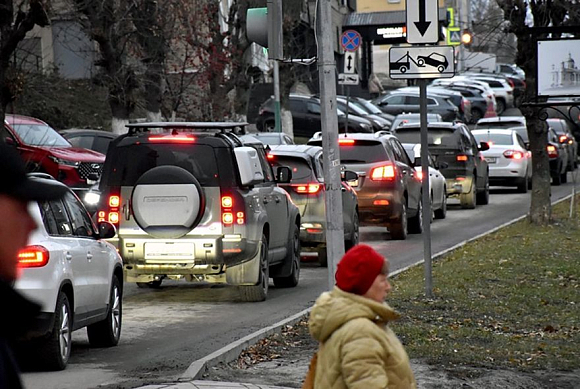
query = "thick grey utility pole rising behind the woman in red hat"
xmin=316 ymin=0 xmax=344 ymax=289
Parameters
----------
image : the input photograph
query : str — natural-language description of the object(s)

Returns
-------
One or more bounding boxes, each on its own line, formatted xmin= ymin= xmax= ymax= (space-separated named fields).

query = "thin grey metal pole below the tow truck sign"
xmin=419 ymin=79 xmax=433 ymax=298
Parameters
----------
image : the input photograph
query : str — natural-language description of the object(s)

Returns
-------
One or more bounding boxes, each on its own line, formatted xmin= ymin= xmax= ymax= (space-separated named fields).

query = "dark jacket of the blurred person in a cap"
xmin=0 ymin=280 xmax=40 ymax=389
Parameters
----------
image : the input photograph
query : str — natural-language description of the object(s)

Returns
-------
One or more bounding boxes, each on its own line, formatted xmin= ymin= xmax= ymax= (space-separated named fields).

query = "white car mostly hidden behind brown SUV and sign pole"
xmin=403 ymin=143 xmax=447 ymax=219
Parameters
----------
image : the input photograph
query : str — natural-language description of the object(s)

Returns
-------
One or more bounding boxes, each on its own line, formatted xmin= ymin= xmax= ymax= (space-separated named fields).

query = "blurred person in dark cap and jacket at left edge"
xmin=0 ymin=141 xmax=66 ymax=389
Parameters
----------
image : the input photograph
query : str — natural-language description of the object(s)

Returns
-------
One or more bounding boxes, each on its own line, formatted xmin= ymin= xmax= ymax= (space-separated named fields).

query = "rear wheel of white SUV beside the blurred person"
xmin=38 ymin=292 xmax=72 ymax=370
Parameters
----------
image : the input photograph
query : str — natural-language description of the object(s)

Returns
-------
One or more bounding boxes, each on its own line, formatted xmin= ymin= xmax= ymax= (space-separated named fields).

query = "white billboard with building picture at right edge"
xmin=538 ymin=39 xmax=580 ymax=96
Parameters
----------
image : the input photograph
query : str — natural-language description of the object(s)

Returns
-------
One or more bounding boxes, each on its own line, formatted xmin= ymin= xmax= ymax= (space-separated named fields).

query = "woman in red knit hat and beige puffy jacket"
xmin=308 ymin=244 xmax=417 ymax=389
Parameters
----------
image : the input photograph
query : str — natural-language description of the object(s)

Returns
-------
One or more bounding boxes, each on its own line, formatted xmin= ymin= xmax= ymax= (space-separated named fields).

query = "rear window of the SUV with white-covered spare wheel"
xmin=101 ymin=143 xmax=227 ymax=186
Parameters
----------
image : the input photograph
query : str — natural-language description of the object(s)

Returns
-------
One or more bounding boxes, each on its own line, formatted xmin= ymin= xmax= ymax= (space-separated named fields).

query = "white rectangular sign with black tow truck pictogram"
xmin=389 ymin=46 xmax=455 ymax=79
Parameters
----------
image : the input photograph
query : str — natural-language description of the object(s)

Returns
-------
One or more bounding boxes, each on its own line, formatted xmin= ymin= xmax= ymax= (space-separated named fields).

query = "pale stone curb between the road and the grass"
xmin=178 ymin=189 xmax=572 ymax=382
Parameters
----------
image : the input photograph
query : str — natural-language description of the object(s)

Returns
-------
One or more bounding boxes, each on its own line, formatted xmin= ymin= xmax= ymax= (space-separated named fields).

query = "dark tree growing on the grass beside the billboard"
xmin=496 ymin=0 xmax=578 ymax=225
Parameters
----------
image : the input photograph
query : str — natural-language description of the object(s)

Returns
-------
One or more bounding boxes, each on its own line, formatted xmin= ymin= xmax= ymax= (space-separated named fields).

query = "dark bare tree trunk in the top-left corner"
xmin=0 ymin=0 xmax=49 ymax=123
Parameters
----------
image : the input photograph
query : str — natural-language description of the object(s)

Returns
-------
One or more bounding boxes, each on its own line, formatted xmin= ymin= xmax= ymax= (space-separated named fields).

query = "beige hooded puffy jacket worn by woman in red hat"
xmin=308 ymin=287 xmax=417 ymax=389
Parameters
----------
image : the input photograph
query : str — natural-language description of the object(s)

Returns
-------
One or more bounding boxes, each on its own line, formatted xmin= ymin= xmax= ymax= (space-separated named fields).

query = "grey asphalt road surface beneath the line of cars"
xmin=23 ymin=177 xmax=572 ymax=389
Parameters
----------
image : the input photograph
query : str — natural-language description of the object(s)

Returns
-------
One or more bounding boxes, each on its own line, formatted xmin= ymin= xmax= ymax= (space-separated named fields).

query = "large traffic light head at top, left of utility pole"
xmin=246 ymin=4 xmax=283 ymax=60
